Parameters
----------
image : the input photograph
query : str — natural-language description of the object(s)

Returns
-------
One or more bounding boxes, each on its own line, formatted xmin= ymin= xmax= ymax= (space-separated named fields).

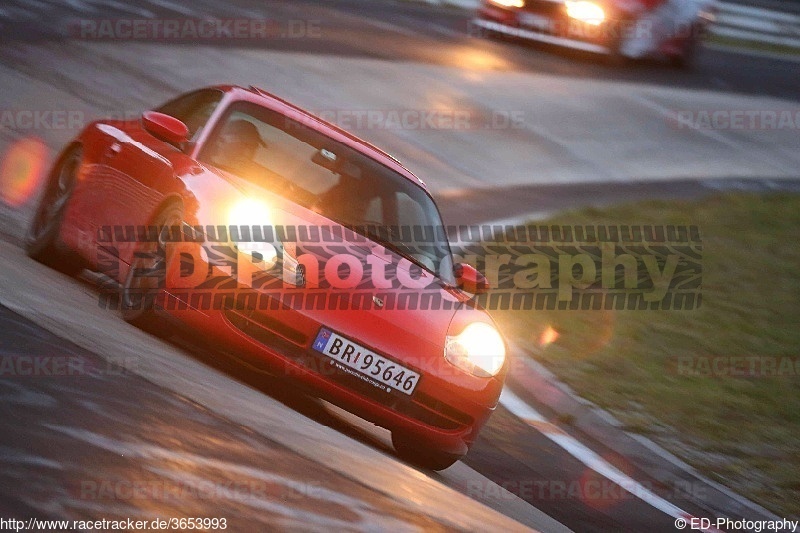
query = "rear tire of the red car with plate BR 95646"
xmin=25 ymin=146 xmax=84 ymax=276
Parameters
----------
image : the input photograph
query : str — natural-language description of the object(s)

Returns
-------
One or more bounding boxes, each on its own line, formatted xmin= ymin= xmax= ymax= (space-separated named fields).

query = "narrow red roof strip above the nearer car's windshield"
xmin=211 ymin=85 xmax=428 ymax=191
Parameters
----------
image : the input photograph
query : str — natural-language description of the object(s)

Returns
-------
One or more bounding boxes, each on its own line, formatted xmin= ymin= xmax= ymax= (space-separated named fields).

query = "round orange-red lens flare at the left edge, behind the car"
xmin=0 ymin=137 xmax=48 ymax=207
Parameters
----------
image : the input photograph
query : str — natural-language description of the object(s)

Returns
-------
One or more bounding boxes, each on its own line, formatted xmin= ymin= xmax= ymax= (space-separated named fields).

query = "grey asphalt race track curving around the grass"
xmin=0 ymin=0 xmax=800 ymax=532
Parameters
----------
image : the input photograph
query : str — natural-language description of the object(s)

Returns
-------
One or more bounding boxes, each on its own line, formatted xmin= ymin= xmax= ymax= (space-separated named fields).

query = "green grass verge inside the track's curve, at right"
xmin=493 ymin=194 xmax=800 ymax=516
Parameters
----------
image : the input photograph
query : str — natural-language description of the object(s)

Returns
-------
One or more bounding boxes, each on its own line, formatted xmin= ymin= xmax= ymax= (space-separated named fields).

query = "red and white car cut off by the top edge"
xmin=473 ymin=0 xmax=717 ymax=66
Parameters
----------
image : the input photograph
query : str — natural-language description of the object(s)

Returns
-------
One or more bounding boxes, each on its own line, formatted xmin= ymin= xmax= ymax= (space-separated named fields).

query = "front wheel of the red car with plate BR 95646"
xmin=119 ymin=202 xmax=183 ymax=335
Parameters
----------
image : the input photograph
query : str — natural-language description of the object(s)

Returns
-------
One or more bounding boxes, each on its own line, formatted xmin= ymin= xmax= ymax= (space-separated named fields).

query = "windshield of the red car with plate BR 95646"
xmin=198 ymin=102 xmax=454 ymax=283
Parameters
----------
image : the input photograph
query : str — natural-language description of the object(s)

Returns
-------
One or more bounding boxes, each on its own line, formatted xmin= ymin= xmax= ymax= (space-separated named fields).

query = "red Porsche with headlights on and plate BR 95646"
xmin=27 ymin=86 xmax=508 ymax=470
